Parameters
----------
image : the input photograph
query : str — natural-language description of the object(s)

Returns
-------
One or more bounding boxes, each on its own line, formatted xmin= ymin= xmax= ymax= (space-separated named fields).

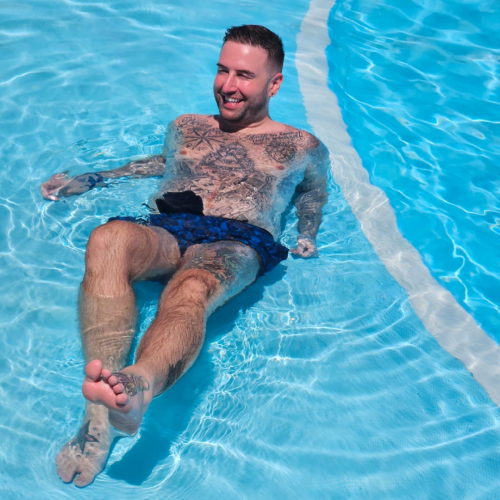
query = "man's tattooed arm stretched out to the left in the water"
xmin=40 ymin=154 xmax=165 ymax=201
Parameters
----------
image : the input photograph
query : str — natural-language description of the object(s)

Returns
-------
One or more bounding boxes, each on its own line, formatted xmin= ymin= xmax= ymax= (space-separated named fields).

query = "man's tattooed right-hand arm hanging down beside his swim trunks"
xmin=292 ymin=142 xmax=329 ymax=257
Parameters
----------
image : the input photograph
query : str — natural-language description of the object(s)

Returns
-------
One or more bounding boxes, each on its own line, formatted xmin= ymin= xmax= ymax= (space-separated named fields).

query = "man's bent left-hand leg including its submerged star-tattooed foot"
xmin=56 ymin=221 xmax=180 ymax=486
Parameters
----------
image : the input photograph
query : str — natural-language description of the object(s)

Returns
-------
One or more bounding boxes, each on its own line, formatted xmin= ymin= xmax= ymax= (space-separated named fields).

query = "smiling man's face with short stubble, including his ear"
xmin=214 ymin=42 xmax=281 ymax=125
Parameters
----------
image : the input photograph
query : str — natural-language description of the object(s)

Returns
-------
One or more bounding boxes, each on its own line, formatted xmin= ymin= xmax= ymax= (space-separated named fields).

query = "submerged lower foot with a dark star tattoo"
xmin=56 ymin=403 xmax=118 ymax=487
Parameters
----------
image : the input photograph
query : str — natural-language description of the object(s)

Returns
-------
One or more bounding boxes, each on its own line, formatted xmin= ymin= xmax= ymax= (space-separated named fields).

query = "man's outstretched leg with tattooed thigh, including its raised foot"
xmin=84 ymin=241 xmax=260 ymax=433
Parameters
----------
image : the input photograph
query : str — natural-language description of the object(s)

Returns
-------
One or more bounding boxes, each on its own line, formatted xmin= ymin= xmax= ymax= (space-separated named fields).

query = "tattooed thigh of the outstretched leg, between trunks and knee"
xmin=179 ymin=241 xmax=260 ymax=310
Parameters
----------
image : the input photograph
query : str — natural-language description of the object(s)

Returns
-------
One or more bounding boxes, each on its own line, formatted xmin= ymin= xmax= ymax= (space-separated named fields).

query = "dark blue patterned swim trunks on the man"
xmin=109 ymin=212 xmax=288 ymax=276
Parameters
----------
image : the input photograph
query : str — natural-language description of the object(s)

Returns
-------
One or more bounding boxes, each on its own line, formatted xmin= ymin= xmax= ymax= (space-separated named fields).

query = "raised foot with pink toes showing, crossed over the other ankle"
xmin=82 ymin=359 xmax=153 ymax=434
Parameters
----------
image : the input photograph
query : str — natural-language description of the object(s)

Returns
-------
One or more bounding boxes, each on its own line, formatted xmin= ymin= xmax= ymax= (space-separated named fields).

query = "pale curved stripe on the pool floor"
xmin=296 ymin=0 xmax=500 ymax=406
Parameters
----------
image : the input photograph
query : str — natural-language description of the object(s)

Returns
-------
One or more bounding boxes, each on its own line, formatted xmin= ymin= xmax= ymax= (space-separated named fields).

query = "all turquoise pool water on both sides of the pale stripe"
xmin=0 ymin=0 xmax=500 ymax=500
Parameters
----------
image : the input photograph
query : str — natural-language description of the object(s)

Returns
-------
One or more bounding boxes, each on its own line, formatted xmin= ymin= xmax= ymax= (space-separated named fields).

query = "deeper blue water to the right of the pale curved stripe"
xmin=327 ymin=0 xmax=500 ymax=342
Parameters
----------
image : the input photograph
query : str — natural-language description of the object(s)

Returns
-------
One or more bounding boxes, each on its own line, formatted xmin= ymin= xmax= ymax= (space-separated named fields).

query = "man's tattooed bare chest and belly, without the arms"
xmin=163 ymin=115 xmax=307 ymax=219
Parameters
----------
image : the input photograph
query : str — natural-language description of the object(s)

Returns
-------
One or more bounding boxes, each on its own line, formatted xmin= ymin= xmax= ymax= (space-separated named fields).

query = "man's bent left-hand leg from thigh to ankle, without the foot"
xmin=80 ymin=221 xmax=180 ymax=371
